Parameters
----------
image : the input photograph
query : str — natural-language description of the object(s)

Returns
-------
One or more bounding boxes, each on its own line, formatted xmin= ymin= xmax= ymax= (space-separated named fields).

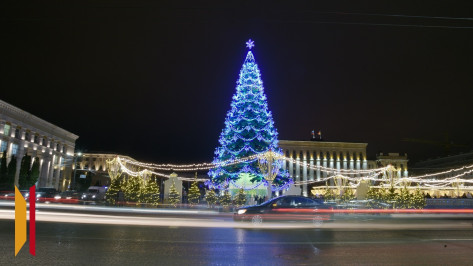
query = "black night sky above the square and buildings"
xmin=0 ymin=0 xmax=473 ymax=163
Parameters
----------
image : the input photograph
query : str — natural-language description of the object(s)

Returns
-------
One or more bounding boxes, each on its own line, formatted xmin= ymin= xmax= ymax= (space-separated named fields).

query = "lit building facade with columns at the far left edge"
xmin=0 ymin=100 xmax=79 ymax=191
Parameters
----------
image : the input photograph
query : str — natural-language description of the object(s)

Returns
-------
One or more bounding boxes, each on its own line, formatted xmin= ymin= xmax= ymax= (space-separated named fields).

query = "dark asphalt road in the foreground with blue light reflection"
xmin=0 ymin=214 xmax=473 ymax=265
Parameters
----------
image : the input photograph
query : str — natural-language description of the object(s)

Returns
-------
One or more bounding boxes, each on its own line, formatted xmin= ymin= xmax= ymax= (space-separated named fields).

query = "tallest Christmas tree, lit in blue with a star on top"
xmin=209 ymin=40 xmax=292 ymax=190
